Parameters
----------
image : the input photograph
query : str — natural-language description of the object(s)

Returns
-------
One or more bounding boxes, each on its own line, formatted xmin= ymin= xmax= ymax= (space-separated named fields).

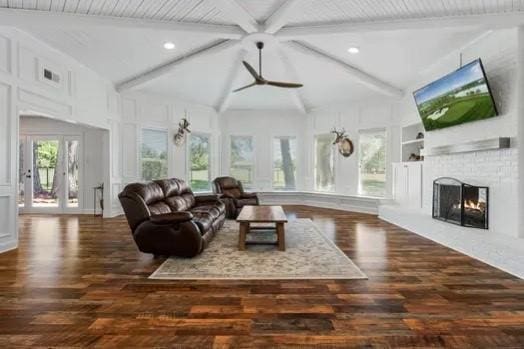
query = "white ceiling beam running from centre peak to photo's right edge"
xmin=275 ymin=12 xmax=524 ymax=41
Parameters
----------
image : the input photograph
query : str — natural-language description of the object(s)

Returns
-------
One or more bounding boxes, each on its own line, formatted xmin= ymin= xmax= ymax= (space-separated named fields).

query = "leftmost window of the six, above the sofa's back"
xmin=140 ymin=129 xmax=167 ymax=181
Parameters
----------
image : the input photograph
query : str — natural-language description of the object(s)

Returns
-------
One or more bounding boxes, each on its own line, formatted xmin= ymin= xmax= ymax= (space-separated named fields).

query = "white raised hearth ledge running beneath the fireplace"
xmin=379 ymin=205 xmax=524 ymax=279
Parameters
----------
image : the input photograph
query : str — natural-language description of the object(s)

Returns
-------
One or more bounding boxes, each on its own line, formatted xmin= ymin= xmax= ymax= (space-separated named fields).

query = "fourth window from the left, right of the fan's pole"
xmin=273 ymin=137 xmax=297 ymax=190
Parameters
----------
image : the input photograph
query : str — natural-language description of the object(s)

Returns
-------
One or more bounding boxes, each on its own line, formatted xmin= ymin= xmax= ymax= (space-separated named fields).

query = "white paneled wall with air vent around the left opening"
xmin=0 ymin=27 xmax=119 ymax=252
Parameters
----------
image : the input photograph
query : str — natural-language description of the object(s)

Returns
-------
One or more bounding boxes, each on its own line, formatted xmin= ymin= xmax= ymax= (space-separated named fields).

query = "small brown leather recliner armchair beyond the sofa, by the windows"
xmin=213 ymin=177 xmax=259 ymax=219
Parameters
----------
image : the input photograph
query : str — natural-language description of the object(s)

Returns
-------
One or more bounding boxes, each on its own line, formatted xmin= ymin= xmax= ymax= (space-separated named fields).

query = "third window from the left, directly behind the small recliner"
xmin=229 ymin=136 xmax=254 ymax=187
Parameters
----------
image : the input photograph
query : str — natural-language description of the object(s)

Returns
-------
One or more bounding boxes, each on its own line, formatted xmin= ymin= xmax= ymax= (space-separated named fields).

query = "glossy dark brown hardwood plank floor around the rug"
xmin=0 ymin=206 xmax=524 ymax=348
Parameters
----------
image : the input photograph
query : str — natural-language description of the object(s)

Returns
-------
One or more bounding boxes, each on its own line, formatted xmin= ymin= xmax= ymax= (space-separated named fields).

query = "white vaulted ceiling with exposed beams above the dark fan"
xmin=0 ymin=0 xmax=524 ymax=111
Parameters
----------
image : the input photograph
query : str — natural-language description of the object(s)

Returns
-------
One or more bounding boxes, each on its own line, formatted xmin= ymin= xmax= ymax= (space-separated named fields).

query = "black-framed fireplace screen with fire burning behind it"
xmin=433 ymin=177 xmax=489 ymax=229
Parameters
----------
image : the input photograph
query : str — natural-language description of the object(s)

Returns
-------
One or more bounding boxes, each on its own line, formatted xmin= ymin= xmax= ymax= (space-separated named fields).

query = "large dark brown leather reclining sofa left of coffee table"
xmin=118 ymin=178 xmax=226 ymax=257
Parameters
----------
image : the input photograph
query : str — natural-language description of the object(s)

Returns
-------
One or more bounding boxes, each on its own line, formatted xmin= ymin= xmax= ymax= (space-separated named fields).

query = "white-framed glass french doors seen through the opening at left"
xmin=18 ymin=135 xmax=81 ymax=213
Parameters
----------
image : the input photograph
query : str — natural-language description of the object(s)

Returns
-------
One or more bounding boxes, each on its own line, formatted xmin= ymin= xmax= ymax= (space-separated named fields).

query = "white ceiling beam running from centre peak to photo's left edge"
xmin=0 ymin=8 xmax=245 ymax=39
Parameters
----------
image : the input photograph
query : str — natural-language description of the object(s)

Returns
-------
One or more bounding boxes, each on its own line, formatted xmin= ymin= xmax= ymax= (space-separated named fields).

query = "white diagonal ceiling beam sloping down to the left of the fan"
xmin=116 ymin=40 xmax=239 ymax=92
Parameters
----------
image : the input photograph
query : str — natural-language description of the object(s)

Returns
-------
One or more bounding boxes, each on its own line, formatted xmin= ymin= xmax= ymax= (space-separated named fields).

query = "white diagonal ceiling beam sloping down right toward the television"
xmin=283 ymin=41 xmax=404 ymax=98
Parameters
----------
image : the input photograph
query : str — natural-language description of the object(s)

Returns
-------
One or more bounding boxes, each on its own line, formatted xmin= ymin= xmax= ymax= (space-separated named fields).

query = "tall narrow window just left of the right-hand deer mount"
xmin=315 ymin=133 xmax=335 ymax=191
